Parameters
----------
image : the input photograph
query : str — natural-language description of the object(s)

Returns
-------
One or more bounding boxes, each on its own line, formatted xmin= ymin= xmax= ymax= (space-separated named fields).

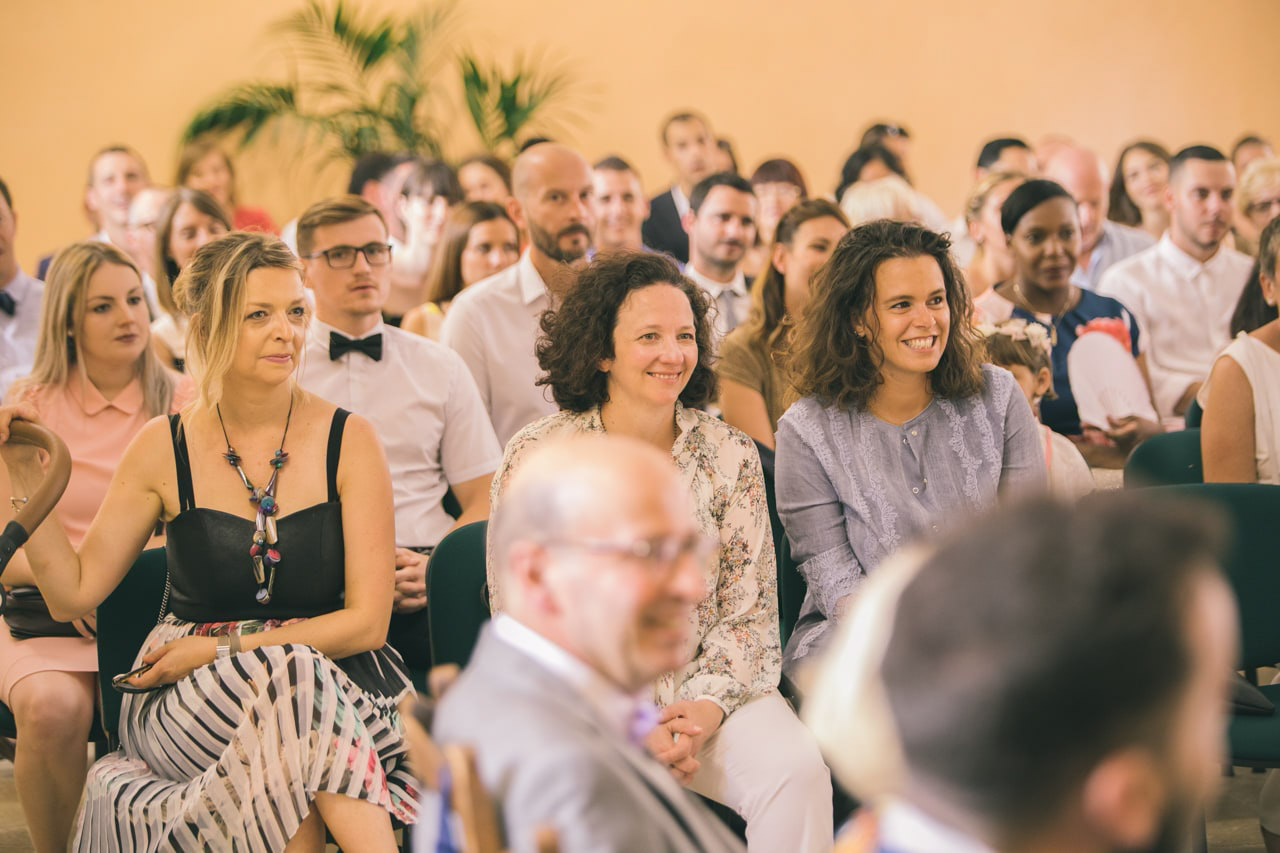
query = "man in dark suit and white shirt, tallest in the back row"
xmin=643 ymin=111 xmax=718 ymax=264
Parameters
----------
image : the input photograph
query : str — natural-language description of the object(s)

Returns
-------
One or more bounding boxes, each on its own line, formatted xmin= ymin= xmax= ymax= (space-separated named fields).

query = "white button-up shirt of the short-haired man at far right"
xmin=1098 ymin=233 xmax=1253 ymax=418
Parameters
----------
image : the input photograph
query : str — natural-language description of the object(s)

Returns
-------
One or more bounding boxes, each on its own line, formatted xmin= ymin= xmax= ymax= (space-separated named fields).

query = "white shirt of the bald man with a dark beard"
xmin=440 ymin=250 xmax=559 ymax=446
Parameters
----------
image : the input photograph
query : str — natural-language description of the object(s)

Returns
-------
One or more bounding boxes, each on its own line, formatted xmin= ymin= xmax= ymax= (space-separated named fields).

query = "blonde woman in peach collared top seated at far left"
xmin=0 ymin=241 xmax=191 ymax=853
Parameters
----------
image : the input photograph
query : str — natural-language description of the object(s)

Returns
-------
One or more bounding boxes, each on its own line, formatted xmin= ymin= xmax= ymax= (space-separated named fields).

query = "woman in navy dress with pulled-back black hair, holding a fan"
xmin=977 ymin=178 xmax=1161 ymax=458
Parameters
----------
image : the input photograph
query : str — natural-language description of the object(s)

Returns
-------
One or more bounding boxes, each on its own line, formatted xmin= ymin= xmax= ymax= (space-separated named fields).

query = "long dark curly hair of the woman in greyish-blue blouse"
xmin=790 ymin=219 xmax=983 ymax=409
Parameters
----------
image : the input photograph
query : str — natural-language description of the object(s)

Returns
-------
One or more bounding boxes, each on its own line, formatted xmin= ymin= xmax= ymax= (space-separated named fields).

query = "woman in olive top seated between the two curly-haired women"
xmin=716 ymin=199 xmax=849 ymax=448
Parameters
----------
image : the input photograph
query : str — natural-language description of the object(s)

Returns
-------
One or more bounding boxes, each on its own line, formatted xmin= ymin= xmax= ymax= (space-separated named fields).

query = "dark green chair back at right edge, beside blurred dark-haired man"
xmin=1152 ymin=483 xmax=1280 ymax=670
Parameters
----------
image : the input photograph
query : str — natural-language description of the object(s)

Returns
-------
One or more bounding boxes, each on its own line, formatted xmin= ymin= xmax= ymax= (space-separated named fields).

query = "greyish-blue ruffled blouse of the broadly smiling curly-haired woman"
xmin=776 ymin=365 xmax=1047 ymax=672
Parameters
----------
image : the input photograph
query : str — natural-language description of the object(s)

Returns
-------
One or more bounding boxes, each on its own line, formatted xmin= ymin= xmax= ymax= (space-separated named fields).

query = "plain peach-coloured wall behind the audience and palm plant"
xmin=0 ymin=0 xmax=1280 ymax=269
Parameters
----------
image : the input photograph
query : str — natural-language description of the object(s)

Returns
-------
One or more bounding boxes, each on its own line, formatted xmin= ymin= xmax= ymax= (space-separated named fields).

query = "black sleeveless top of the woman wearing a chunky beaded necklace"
xmin=165 ymin=409 xmax=349 ymax=622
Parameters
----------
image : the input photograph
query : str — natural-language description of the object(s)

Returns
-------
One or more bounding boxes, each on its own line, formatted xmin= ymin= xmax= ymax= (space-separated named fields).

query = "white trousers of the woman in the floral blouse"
xmin=689 ymin=693 xmax=833 ymax=853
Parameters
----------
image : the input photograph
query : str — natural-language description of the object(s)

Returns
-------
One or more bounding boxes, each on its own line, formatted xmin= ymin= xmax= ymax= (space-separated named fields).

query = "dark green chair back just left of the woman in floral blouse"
xmin=426 ymin=521 xmax=489 ymax=666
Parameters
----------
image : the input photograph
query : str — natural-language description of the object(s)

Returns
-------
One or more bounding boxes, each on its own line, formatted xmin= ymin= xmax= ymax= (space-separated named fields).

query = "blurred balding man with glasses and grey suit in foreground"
xmin=434 ymin=437 xmax=741 ymax=853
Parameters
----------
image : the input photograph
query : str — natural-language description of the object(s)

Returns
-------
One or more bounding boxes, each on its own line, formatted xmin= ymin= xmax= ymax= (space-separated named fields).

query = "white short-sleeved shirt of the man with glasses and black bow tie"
xmin=298 ymin=313 xmax=502 ymax=547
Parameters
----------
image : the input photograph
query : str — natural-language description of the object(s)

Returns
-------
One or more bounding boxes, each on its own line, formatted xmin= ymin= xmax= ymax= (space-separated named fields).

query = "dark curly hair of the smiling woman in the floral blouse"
xmin=536 ymin=252 xmax=717 ymax=412
